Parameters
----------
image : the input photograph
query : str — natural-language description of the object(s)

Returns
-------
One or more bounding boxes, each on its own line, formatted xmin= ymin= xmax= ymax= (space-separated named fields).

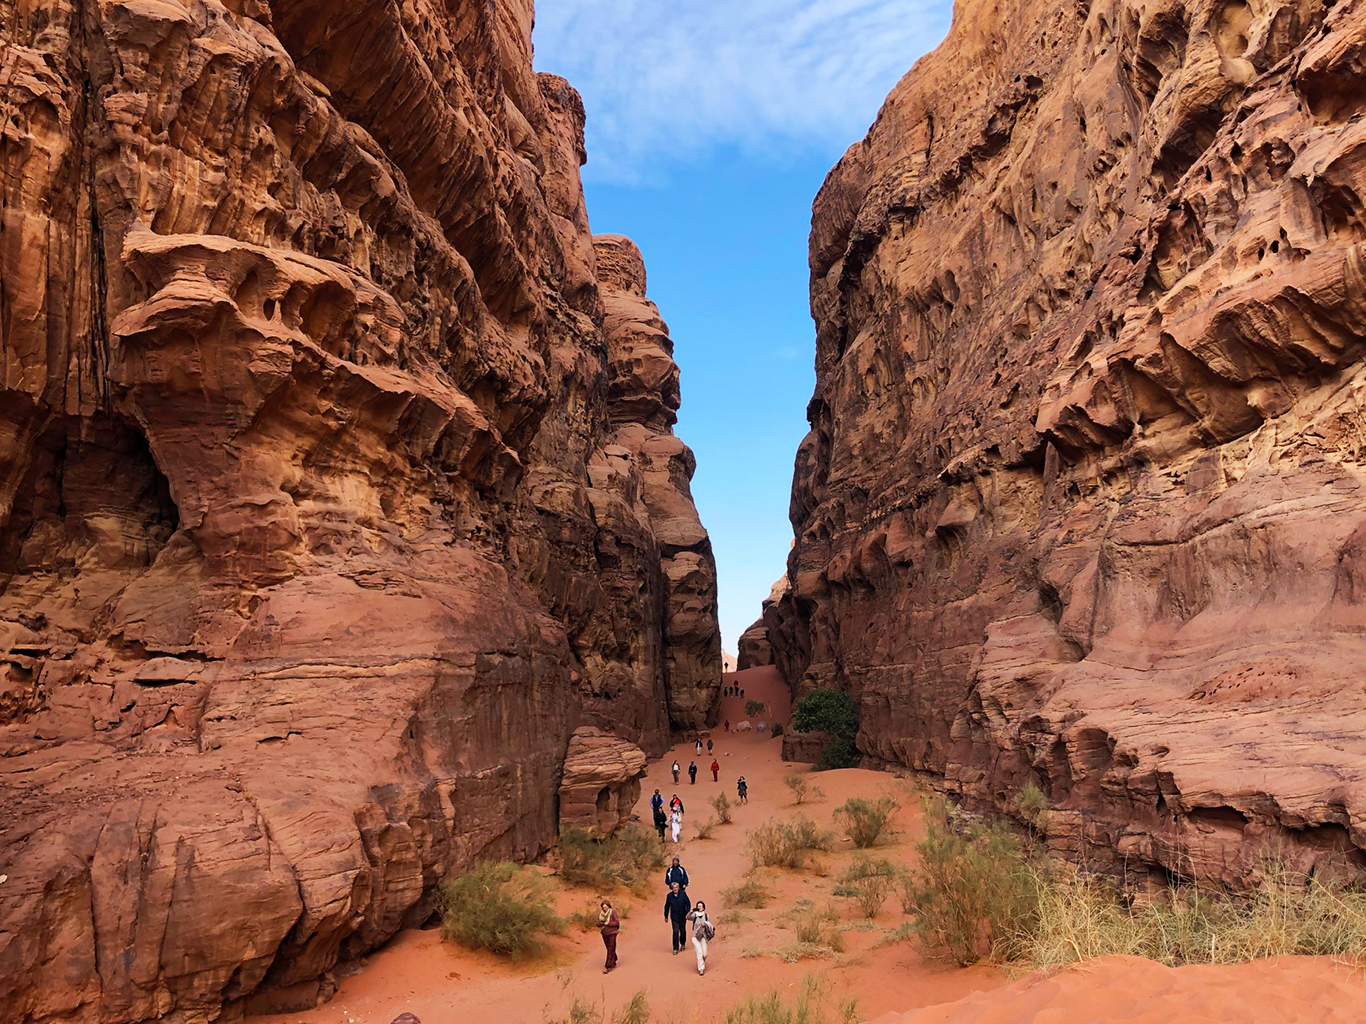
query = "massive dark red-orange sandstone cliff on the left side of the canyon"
xmin=0 ymin=0 xmax=720 ymax=1024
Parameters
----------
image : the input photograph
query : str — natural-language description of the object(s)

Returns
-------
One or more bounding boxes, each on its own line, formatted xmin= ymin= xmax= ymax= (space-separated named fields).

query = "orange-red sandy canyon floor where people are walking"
xmin=250 ymin=669 xmax=1366 ymax=1024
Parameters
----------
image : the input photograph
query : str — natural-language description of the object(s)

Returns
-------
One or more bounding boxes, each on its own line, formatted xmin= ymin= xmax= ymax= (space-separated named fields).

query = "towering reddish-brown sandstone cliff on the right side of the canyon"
xmin=770 ymin=0 xmax=1366 ymax=882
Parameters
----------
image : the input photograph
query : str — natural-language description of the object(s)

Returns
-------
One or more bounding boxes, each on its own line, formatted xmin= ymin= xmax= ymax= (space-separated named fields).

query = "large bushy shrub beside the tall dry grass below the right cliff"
xmin=903 ymin=800 xmax=1038 ymax=965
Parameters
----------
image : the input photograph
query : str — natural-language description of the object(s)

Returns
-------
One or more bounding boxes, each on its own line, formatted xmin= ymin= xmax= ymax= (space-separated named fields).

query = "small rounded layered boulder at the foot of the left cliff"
xmin=560 ymin=725 xmax=646 ymax=836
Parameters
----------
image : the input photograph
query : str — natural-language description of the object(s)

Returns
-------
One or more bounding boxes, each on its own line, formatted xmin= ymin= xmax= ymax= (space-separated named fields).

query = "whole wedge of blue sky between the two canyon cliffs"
xmin=533 ymin=0 xmax=951 ymax=653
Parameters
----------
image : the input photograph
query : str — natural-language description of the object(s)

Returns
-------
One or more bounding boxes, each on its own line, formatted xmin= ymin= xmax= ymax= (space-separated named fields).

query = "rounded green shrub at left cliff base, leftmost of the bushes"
xmin=437 ymin=860 xmax=564 ymax=960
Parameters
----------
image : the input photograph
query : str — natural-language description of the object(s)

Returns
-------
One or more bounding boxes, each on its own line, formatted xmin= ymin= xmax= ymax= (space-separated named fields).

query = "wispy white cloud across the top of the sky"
xmin=534 ymin=0 xmax=951 ymax=182
